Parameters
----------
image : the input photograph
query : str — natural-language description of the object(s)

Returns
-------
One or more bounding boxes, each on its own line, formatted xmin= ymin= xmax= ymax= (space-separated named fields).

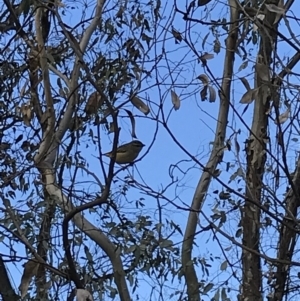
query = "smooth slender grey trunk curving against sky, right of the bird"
xmin=182 ymin=0 xmax=239 ymax=301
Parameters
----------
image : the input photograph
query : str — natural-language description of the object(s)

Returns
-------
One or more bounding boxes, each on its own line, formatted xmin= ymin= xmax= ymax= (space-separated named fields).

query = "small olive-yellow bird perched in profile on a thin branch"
xmin=103 ymin=140 xmax=145 ymax=164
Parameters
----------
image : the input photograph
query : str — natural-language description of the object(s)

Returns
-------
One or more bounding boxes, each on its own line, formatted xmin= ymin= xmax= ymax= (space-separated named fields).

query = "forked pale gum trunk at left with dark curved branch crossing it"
xmin=30 ymin=0 xmax=131 ymax=301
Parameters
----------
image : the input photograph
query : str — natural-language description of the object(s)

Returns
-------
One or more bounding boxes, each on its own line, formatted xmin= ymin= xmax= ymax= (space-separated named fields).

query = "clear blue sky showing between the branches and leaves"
xmin=1 ymin=1 xmax=300 ymax=300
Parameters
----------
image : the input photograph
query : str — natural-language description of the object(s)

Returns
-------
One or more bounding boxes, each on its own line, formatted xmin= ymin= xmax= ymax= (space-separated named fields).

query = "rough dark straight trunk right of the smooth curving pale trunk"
xmin=240 ymin=0 xmax=278 ymax=301
